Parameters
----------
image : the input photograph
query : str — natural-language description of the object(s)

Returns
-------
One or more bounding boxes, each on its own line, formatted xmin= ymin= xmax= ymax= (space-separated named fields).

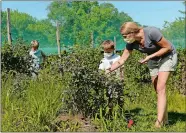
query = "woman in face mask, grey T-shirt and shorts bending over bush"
xmin=106 ymin=22 xmax=177 ymax=128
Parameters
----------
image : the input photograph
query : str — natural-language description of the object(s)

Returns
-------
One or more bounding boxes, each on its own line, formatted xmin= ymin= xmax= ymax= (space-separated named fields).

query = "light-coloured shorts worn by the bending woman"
xmin=148 ymin=53 xmax=178 ymax=76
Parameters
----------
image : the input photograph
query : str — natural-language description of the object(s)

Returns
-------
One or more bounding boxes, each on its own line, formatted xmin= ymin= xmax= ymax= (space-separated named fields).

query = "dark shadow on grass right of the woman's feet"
xmin=168 ymin=112 xmax=186 ymax=125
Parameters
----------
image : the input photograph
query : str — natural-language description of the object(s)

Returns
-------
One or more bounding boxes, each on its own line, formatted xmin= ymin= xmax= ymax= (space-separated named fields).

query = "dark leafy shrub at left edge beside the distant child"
xmin=1 ymin=44 xmax=31 ymax=75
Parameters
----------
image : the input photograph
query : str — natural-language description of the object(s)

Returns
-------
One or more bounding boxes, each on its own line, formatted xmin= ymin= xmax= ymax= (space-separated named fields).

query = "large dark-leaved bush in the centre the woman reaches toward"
xmin=42 ymin=46 xmax=124 ymax=116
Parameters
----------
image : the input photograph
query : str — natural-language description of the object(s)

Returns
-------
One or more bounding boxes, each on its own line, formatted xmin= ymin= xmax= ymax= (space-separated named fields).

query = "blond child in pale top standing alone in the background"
xmin=29 ymin=40 xmax=46 ymax=77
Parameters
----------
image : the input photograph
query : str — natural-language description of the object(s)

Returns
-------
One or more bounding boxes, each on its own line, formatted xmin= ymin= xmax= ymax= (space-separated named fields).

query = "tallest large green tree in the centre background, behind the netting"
xmin=48 ymin=1 xmax=133 ymax=45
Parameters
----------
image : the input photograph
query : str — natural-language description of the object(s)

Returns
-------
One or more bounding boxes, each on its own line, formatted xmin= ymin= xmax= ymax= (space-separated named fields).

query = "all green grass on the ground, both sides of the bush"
xmin=1 ymin=75 xmax=186 ymax=132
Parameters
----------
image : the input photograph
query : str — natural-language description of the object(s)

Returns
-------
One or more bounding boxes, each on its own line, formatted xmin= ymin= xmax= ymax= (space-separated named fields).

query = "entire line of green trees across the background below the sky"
xmin=1 ymin=1 xmax=185 ymax=47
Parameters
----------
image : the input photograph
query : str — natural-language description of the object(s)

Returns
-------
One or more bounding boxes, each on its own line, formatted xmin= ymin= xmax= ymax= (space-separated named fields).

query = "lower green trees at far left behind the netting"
xmin=1 ymin=10 xmax=55 ymax=46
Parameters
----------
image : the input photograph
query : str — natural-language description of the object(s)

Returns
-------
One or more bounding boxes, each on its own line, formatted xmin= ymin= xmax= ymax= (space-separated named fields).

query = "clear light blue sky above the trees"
xmin=1 ymin=1 xmax=185 ymax=29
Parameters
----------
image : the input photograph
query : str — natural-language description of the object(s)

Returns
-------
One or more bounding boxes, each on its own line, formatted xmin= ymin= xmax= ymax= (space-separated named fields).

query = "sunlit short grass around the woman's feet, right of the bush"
xmin=94 ymin=85 xmax=186 ymax=132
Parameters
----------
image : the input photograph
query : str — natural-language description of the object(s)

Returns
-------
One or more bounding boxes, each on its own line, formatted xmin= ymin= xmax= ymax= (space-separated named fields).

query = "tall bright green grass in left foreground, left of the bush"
xmin=2 ymin=73 xmax=62 ymax=132
